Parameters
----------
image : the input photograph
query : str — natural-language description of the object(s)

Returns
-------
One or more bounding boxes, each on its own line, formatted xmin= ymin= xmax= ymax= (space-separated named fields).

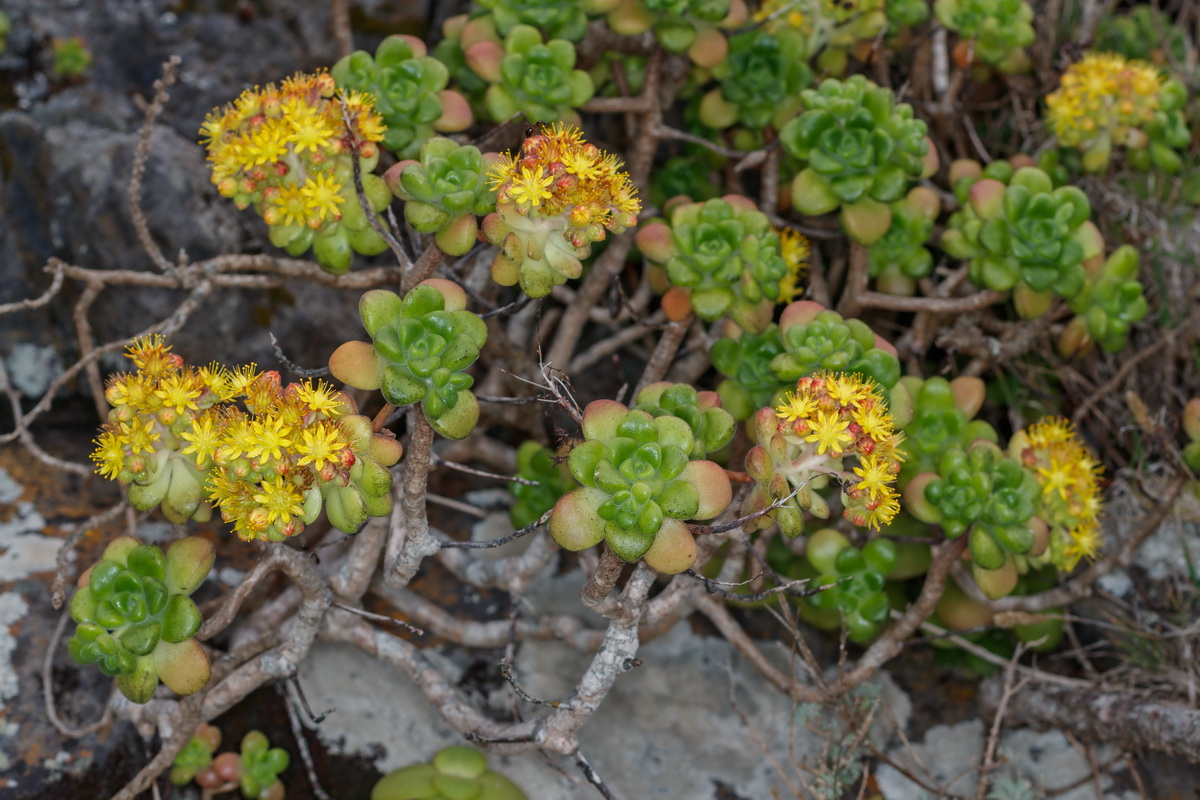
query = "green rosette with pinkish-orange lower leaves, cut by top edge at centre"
xmin=605 ymin=0 xmax=746 ymax=68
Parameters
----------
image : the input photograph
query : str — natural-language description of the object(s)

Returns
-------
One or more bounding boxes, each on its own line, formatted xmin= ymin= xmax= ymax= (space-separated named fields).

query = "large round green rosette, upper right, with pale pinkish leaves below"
xmin=779 ymin=76 xmax=937 ymax=245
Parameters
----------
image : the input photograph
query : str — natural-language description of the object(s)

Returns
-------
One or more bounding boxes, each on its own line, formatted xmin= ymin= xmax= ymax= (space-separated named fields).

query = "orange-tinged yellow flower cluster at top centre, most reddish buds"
xmin=487 ymin=122 xmax=642 ymax=247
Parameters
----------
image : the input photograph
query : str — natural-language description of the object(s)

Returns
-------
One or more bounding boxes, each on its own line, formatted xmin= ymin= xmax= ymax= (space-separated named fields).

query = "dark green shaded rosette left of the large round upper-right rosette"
xmin=700 ymin=28 xmax=812 ymax=130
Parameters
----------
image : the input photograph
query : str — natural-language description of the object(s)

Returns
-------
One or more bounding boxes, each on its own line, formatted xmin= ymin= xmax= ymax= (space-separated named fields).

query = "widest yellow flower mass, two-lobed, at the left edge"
xmin=91 ymin=336 xmax=356 ymax=541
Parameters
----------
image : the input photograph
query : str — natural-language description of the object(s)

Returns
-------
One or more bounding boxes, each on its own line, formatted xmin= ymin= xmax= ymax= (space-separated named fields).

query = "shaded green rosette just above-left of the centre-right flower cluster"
xmin=708 ymin=323 xmax=792 ymax=421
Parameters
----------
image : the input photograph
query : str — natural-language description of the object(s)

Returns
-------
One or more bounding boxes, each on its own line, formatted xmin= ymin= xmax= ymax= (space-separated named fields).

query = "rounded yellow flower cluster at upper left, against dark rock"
xmin=200 ymin=72 xmax=386 ymax=230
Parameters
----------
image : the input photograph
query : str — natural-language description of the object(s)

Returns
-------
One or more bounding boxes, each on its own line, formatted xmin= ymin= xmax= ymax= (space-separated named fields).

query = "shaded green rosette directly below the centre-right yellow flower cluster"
xmin=805 ymin=528 xmax=896 ymax=644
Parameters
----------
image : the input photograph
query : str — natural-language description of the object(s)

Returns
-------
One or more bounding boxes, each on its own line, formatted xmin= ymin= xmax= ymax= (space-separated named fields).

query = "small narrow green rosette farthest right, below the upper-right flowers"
xmin=1058 ymin=245 xmax=1150 ymax=356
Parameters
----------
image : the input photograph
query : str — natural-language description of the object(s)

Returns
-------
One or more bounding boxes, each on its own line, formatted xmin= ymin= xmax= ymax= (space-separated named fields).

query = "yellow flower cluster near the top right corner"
xmin=1046 ymin=53 xmax=1163 ymax=148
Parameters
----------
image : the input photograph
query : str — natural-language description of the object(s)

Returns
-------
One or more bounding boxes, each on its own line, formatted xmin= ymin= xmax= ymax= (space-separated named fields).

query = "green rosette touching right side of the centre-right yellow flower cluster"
xmin=898 ymin=375 xmax=998 ymax=485
